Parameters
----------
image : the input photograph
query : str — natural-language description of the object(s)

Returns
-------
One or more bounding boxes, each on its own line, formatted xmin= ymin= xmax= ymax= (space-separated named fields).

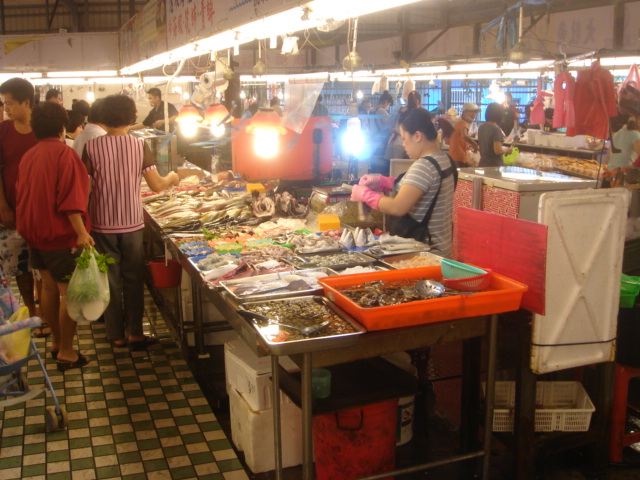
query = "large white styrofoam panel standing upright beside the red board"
xmin=531 ymin=188 xmax=630 ymax=374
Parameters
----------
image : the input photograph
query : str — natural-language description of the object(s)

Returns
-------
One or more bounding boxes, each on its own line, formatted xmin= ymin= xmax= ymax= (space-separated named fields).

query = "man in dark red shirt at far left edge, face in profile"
xmin=0 ymin=78 xmax=39 ymax=335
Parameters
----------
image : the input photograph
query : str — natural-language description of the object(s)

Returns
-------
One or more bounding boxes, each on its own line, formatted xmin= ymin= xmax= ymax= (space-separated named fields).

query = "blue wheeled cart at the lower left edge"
xmin=0 ymin=273 xmax=68 ymax=432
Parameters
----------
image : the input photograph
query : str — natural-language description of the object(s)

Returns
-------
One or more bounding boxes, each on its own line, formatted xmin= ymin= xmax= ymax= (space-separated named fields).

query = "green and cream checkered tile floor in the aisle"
xmin=0 ymin=288 xmax=248 ymax=480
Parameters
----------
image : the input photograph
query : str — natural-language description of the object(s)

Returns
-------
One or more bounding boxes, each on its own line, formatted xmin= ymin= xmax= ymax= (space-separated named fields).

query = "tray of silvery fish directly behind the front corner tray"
xmin=220 ymin=267 xmax=336 ymax=302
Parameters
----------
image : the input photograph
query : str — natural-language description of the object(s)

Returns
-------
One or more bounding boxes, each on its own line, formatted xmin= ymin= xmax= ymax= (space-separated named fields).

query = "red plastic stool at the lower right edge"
xmin=609 ymin=363 xmax=640 ymax=463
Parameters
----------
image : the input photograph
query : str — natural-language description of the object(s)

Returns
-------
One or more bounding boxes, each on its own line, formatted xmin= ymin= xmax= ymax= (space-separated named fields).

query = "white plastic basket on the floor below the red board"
xmin=493 ymin=382 xmax=596 ymax=432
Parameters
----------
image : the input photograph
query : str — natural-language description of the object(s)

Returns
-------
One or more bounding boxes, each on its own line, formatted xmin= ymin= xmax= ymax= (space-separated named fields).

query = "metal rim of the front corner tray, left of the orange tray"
xmin=238 ymin=296 xmax=366 ymax=355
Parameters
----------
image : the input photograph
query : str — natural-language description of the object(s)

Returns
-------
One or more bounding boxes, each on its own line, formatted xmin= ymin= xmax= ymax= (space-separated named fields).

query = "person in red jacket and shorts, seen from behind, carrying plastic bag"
xmin=17 ymin=102 xmax=94 ymax=371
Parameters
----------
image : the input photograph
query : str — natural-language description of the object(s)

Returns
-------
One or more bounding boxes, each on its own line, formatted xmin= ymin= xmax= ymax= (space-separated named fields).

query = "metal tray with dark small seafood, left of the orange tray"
xmin=238 ymin=296 xmax=365 ymax=355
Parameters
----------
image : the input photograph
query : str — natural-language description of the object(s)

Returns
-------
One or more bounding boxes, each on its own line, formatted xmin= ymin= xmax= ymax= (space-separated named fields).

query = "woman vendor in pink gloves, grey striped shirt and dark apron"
xmin=351 ymin=108 xmax=457 ymax=257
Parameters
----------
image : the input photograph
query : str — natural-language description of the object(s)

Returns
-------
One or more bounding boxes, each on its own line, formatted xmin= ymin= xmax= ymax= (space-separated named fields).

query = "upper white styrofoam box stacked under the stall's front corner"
xmin=224 ymin=338 xmax=300 ymax=411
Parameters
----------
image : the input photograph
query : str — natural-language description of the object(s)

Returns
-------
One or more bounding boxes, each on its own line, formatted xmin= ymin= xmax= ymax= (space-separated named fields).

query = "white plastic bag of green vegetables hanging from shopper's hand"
xmin=67 ymin=247 xmax=114 ymax=323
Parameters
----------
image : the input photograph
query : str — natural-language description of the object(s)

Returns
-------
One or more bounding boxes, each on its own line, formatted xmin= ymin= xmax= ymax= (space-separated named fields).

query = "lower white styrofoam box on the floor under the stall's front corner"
xmin=229 ymin=388 xmax=302 ymax=473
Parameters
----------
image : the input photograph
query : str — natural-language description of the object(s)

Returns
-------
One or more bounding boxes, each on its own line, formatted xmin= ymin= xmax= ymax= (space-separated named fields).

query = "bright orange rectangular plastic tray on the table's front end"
xmin=318 ymin=267 xmax=527 ymax=330
